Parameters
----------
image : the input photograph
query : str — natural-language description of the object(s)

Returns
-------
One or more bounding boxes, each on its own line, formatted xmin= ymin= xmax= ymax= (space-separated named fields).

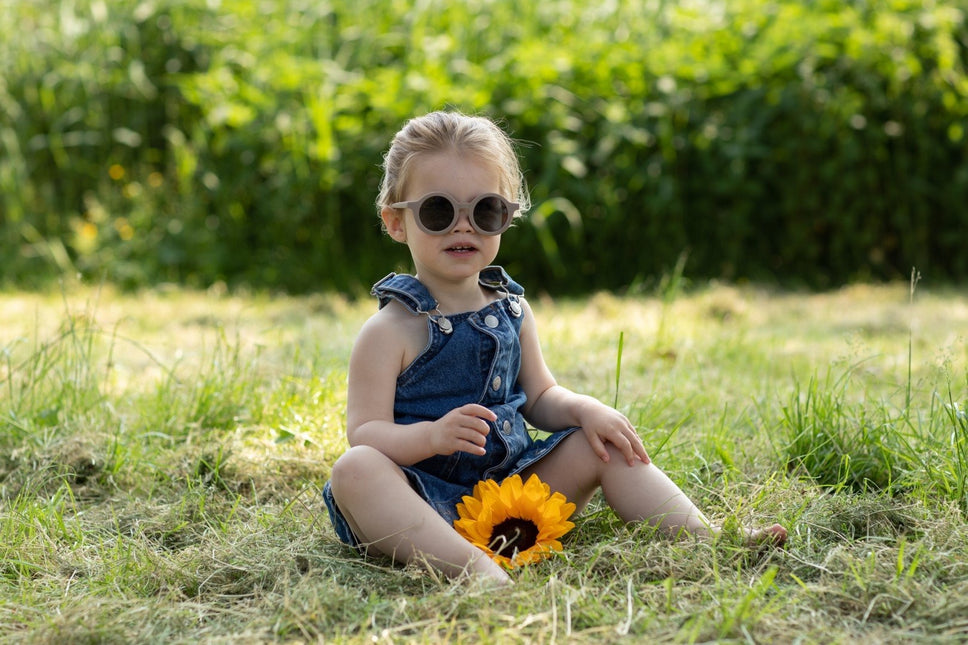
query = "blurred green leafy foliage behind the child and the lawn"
xmin=0 ymin=0 xmax=968 ymax=292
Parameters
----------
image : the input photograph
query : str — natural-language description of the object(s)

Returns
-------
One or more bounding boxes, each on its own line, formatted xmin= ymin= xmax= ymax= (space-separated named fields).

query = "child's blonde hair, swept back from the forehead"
xmin=376 ymin=112 xmax=530 ymax=217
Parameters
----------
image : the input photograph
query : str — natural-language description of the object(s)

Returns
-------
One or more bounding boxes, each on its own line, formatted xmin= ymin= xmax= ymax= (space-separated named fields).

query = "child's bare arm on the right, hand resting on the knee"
xmin=518 ymin=301 xmax=649 ymax=464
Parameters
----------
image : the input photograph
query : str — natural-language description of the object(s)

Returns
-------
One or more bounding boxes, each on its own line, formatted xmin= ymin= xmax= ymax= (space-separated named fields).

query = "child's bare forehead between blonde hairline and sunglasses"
xmin=406 ymin=152 xmax=501 ymax=201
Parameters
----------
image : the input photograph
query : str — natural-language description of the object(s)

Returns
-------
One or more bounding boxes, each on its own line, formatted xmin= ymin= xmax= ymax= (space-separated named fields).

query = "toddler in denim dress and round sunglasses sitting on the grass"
xmin=324 ymin=112 xmax=787 ymax=583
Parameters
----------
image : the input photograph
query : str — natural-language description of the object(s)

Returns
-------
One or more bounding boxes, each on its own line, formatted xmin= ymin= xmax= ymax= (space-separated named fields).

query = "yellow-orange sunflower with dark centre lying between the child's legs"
xmin=454 ymin=475 xmax=575 ymax=569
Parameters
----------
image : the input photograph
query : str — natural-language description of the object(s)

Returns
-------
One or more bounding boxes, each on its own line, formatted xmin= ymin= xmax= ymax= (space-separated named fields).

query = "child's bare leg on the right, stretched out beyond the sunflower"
xmin=522 ymin=432 xmax=786 ymax=544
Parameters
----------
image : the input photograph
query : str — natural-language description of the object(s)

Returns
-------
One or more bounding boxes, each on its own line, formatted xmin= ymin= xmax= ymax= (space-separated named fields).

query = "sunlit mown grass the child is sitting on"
xmin=0 ymin=282 xmax=968 ymax=643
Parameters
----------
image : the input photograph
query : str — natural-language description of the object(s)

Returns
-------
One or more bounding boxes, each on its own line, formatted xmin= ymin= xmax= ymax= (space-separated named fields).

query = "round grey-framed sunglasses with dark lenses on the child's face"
xmin=390 ymin=193 xmax=521 ymax=235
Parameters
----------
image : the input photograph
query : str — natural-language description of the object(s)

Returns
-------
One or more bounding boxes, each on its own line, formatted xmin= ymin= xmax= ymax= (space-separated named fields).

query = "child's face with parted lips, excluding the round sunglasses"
xmin=381 ymin=152 xmax=501 ymax=280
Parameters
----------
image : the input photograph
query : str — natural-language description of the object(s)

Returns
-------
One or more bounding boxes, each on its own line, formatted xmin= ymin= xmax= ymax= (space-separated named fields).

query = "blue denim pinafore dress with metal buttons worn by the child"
xmin=323 ymin=266 xmax=578 ymax=547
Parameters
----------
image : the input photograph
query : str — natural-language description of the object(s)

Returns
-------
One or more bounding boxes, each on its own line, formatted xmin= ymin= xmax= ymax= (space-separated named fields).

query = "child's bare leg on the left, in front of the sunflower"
xmin=331 ymin=446 xmax=510 ymax=583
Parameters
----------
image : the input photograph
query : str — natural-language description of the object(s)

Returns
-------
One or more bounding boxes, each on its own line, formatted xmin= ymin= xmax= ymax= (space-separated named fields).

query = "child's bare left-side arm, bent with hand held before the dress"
xmin=346 ymin=305 xmax=495 ymax=466
